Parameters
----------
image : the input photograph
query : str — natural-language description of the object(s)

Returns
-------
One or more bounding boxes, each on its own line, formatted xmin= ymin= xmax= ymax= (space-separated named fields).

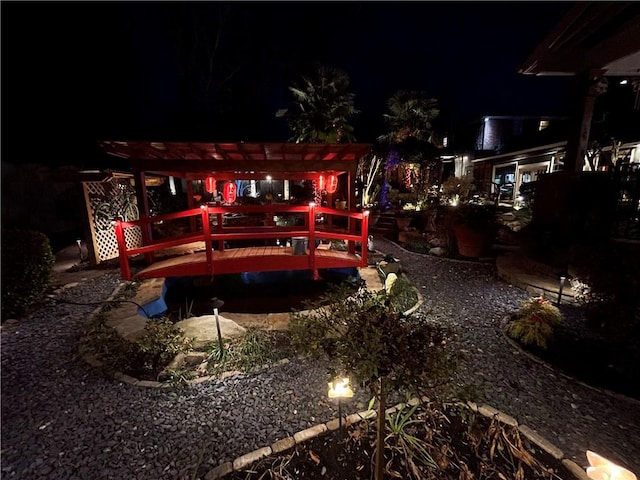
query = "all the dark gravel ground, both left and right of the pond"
xmin=1 ymin=239 xmax=640 ymax=479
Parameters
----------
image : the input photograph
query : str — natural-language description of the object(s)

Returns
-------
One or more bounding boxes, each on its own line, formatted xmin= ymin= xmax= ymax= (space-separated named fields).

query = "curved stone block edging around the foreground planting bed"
xmin=204 ymin=398 xmax=589 ymax=480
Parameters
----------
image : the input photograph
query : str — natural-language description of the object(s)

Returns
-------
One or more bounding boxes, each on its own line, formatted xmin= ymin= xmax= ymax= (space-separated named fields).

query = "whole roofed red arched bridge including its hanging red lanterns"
xmin=101 ymin=141 xmax=371 ymax=279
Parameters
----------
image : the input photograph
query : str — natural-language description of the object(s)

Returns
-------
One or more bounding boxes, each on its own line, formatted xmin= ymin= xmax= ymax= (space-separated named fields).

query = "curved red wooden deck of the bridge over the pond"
xmin=134 ymin=246 xmax=362 ymax=279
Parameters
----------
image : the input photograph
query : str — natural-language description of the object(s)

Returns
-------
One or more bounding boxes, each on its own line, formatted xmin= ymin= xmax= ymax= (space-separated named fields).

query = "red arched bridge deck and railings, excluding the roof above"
xmin=115 ymin=203 xmax=369 ymax=280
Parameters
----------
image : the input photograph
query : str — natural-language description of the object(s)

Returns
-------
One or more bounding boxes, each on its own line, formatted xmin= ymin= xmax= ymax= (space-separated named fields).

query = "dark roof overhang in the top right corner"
xmin=518 ymin=2 xmax=640 ymax=77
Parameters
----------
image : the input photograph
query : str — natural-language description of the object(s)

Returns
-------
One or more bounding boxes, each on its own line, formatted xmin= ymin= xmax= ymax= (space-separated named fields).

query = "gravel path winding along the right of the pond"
xmin=375 ymin=238 xmax=640 ymax=474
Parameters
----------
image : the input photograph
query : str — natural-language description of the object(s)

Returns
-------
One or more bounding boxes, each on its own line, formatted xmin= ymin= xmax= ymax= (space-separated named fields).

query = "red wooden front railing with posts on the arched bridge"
xmin=114 ymin=203 xmax=369 ymax=279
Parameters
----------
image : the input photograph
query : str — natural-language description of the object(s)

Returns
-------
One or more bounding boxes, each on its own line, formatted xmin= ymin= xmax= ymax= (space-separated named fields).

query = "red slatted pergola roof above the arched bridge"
xmin=100 ymin=141 xmax=372 ymax=180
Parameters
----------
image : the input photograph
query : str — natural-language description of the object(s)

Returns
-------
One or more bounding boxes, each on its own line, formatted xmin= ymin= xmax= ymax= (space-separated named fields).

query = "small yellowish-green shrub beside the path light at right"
xmin=506 ymin=297 xmax=562 ymax=348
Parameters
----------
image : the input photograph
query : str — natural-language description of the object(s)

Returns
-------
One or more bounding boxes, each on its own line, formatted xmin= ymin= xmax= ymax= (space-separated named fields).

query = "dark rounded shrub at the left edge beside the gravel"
xmin=2 ymin=229 xmax=55 ymax=320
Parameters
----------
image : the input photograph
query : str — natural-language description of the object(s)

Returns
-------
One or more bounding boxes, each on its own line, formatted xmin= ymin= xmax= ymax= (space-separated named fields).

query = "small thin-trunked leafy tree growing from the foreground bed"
xmin=289 ymin=285 xmax=456 ymax=480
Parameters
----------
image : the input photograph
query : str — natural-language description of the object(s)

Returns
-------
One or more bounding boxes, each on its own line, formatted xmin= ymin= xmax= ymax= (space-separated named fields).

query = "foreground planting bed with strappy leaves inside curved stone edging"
xmin=223 ymin=405 xmax=575 ymax=480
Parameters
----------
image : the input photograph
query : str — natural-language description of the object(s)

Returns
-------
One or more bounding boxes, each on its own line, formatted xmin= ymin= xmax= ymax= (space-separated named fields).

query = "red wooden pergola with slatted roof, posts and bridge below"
xmin=100 ymin=141 xmax=371 ymax=278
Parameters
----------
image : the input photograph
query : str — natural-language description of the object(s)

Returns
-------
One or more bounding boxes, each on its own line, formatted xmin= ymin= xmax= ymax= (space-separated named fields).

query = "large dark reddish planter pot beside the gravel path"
xmin=450 ymin=202 xmax=497 ymax=258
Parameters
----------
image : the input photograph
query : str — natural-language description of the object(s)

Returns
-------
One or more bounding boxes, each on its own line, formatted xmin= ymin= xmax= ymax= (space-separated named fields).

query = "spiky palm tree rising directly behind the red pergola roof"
xmin=276 ymin=65 xmax=359 ymax=143
